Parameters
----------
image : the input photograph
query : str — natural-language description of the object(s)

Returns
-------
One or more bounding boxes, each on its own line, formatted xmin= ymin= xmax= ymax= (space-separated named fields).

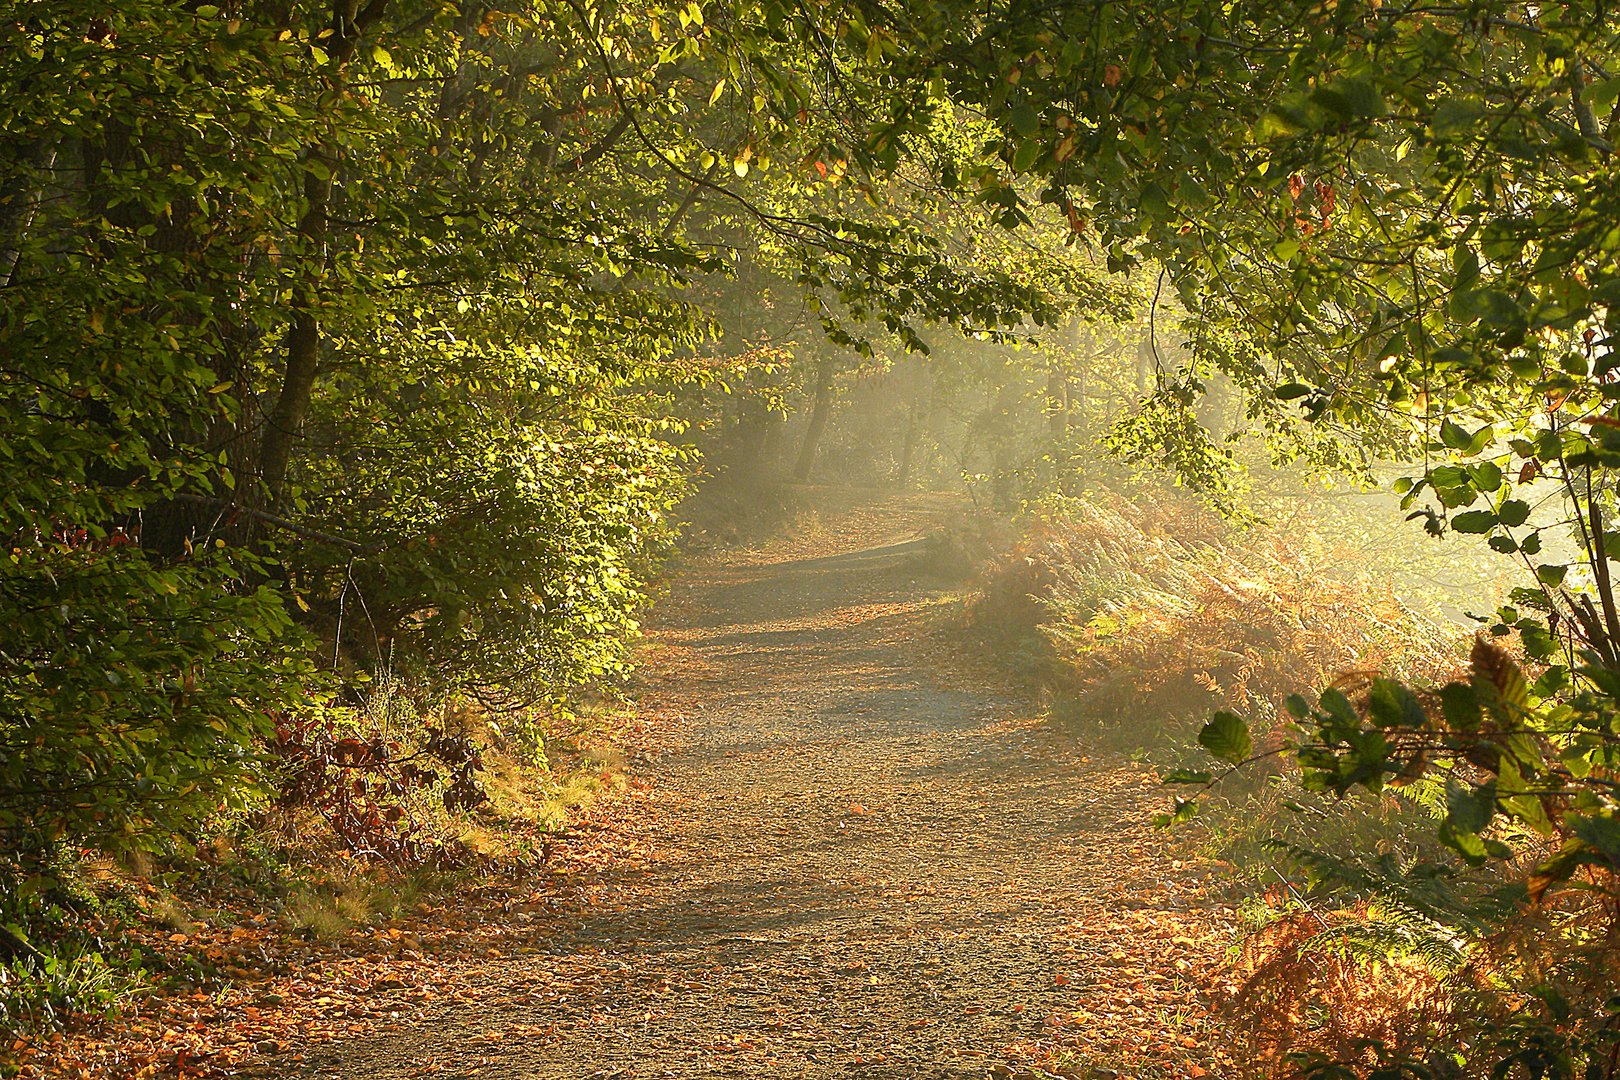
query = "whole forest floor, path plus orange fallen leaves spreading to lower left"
xmin=13 ymin=491 xmax=1236 ymax=1080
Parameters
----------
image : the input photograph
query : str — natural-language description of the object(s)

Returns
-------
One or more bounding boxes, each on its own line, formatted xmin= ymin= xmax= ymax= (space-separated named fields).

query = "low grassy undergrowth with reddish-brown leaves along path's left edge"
xmin=0 ymin=680 xmax=624 ymax=1038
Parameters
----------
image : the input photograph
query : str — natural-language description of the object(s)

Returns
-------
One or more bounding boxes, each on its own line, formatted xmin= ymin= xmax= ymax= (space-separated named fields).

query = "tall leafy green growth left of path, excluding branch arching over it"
xmin=0 ymin=0 xmax=686 ymax=887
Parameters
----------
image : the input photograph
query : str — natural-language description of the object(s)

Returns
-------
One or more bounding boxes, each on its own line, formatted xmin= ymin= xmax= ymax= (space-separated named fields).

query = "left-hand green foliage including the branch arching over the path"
xmin=0 ymin=0 xmax=1110 ymax=878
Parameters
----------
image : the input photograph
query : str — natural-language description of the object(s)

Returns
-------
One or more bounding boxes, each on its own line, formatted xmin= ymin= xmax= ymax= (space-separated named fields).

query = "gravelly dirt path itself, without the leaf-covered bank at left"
xmin=288 ymin=505 xmax=1225 ymax=1080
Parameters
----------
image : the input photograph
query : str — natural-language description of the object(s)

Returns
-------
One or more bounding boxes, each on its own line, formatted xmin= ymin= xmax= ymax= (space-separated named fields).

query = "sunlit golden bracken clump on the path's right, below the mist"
xmin=970 ymin=492 xmax=1466 ymax=746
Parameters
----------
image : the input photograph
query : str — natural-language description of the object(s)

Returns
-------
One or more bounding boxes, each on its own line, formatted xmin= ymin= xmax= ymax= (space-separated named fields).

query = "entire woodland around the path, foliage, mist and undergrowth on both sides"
xmin=9 ymin=0 xmax=1620 ymax=1077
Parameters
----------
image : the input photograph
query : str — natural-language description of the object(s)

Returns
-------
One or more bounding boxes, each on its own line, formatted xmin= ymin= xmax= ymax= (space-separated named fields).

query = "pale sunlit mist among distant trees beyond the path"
xmin=687 ymin=295 xmax=1516 ymax=627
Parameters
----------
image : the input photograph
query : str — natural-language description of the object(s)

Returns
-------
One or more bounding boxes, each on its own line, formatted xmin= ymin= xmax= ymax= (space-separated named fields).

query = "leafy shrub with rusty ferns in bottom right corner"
xmin=1173 ymin=636 xmax=1620 ymax=1077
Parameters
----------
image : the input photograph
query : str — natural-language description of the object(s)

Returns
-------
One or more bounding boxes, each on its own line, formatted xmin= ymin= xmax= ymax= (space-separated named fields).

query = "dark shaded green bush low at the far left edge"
xmin=0 ymin=540 xmax=318 ymax=889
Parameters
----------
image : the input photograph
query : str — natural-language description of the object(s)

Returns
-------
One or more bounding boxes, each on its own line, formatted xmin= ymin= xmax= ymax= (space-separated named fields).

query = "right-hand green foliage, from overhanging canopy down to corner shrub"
xmin=835 ymin=2 xmax=1620 ymax=1075
